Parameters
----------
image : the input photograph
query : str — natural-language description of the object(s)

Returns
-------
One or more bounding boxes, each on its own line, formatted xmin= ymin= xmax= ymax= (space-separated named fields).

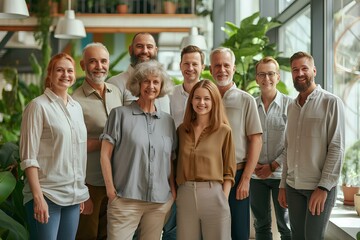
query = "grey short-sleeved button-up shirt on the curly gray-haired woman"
xmin=100 ymin=101 xmax=177 ymax=203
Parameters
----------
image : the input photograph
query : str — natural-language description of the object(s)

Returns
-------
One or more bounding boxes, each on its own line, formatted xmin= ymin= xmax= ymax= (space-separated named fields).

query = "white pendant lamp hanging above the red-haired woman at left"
xmin=54 ymin=0 xmax=86 ymax=39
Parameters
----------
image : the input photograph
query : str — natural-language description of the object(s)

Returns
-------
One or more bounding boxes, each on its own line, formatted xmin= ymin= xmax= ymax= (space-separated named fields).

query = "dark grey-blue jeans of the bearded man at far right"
xmin=286 ymin=185 xmax=336 ymax=240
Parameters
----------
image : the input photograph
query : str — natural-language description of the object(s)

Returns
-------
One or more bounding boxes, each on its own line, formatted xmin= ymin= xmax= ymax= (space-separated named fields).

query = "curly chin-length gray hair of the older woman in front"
xmin=126 ymin=60 xmax=173 ymax=98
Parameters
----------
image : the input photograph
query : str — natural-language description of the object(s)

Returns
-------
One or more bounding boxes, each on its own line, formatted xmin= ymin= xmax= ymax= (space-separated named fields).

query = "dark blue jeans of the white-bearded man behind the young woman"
xmin=229 ymin=169 xmax=250 ymax=240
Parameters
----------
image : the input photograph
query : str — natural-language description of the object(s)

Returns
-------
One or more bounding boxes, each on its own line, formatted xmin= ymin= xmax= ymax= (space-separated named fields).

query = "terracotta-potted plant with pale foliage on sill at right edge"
xmin=341 ymin=140 xmax=360 ymax=206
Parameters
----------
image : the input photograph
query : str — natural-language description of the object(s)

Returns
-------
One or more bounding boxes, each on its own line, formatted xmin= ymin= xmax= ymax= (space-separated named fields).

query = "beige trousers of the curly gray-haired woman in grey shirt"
xmin=107 ymin=197 xmax=174 ymax=240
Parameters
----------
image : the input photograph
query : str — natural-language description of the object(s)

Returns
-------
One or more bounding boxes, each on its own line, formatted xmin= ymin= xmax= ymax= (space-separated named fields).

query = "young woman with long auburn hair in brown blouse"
xmin=176 ymin=80 xmax=236 ymax=240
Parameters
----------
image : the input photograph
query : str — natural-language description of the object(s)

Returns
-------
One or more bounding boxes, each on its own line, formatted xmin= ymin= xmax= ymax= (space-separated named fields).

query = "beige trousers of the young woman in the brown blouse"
xmin=176 ymin=182 xmax=231 ymax=240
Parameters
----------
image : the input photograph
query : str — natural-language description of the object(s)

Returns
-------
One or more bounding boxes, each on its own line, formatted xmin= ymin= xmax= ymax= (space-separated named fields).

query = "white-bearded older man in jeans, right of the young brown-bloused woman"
xmin=210 ymin=47 xmax=262 ymax=240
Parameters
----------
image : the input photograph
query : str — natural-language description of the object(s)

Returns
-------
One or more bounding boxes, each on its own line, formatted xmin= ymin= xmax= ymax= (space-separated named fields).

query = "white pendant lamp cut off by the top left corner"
xmin=0 ymin=0 xmax=29 ymax=19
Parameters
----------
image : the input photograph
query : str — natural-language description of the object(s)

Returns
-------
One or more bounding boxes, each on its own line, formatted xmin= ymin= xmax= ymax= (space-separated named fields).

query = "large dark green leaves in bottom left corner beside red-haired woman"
xmin=0 ymin=142 xmax=28 ymax=240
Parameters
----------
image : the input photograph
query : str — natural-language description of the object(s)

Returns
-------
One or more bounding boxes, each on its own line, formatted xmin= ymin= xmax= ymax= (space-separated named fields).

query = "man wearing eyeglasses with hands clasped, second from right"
xmin=250 ymin=57 xmax=292 ymax=240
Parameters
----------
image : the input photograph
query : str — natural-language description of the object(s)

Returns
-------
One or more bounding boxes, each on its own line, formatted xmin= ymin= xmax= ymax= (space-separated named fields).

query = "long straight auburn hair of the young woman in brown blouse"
xmin=183 ymin=79 xmax=229 ymax=132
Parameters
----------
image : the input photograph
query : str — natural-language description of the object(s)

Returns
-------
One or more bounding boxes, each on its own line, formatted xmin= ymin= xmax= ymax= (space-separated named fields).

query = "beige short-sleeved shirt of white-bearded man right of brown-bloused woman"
xmin=223 ymin=84 xmax=262 ymax=163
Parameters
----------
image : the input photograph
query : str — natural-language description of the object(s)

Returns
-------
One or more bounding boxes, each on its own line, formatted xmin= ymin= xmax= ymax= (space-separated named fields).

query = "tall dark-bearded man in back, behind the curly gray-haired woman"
xmin=107 ymin=32 xmax=170 ymax=113
